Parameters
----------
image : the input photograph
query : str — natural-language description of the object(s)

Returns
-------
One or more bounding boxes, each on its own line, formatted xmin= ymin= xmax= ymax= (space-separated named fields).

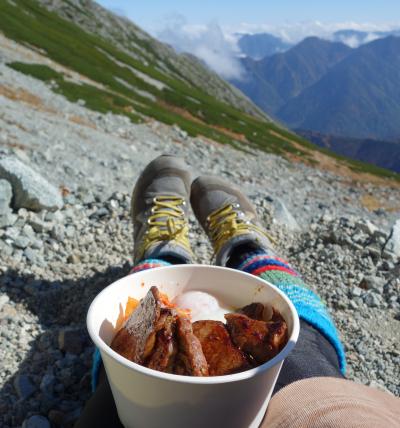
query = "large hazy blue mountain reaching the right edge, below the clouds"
xmin=277 ymin=36 xmax=400 ymax=140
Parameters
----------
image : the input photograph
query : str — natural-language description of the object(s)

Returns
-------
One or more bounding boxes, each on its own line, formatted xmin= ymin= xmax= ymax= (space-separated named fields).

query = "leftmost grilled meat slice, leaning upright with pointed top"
xmin=111 ymin=287 xmax=172 ymax=364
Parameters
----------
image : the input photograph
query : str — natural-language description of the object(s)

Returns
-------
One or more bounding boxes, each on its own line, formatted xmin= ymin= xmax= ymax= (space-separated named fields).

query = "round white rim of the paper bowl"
xmin=86 ymin=264 xmax=300 ymax=385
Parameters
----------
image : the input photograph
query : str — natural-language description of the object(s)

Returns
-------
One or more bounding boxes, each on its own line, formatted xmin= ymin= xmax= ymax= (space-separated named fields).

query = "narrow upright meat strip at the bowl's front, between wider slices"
xmin=175 ymin=315 xmax=208 ymax=376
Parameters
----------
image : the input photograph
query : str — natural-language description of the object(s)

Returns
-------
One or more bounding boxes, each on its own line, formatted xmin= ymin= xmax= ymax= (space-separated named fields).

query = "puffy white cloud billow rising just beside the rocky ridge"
xmin=157 ymin=15 xmax=243 ymax=79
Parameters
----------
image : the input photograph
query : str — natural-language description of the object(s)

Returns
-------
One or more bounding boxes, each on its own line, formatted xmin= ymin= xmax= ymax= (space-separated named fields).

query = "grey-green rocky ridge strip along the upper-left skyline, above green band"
xmin=39 ymin=0 xmax=266 ymax=119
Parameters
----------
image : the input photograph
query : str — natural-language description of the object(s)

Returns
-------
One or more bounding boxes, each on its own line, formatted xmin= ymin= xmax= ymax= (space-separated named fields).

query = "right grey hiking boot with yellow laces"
xmin=190 ymin=176 xmax=274 ymax=266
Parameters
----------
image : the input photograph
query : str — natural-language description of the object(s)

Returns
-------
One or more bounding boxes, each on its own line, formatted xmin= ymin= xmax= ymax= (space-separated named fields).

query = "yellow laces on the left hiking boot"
xmin=140 ymin=196 xmax=191 ymax=260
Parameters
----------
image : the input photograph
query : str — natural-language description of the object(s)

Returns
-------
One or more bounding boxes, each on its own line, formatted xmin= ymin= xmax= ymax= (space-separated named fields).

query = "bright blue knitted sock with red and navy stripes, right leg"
xmin=235 ymin=250 xmax=346 ymax=374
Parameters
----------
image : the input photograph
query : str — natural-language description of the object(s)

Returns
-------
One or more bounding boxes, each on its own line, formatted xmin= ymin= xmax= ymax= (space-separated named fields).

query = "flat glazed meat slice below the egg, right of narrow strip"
xmin=193 ymin=321 xmax=251 ymax=376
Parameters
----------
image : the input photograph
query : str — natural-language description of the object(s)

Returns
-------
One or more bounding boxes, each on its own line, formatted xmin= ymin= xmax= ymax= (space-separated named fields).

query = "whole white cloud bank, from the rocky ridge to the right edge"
xmin=156 ymin=15 xmax=400 ymax=80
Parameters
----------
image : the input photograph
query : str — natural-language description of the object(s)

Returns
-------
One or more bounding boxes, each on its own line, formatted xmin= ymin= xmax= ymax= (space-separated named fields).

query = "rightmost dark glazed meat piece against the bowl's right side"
xmin=225 ymin=310 xmax=288 ymax=364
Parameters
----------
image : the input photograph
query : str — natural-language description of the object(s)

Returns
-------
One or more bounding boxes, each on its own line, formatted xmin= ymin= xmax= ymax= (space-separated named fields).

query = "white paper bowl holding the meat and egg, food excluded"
xmin=87 ymin=265 xmax=299 ymax=428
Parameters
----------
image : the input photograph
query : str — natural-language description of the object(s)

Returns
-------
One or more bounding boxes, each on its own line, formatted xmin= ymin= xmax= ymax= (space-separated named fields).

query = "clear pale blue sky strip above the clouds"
xmin=98 ymin=0 xmax=400 ymax=31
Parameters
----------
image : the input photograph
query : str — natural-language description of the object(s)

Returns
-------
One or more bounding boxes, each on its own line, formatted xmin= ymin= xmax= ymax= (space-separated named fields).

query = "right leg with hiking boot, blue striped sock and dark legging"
xmin=190 ymin=176 xmax=345 ymax=396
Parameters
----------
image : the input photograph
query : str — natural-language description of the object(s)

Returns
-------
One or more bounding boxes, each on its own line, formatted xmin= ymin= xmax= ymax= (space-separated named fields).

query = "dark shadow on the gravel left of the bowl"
xmin=0 ymin=263 xmax=130 ymax=428
